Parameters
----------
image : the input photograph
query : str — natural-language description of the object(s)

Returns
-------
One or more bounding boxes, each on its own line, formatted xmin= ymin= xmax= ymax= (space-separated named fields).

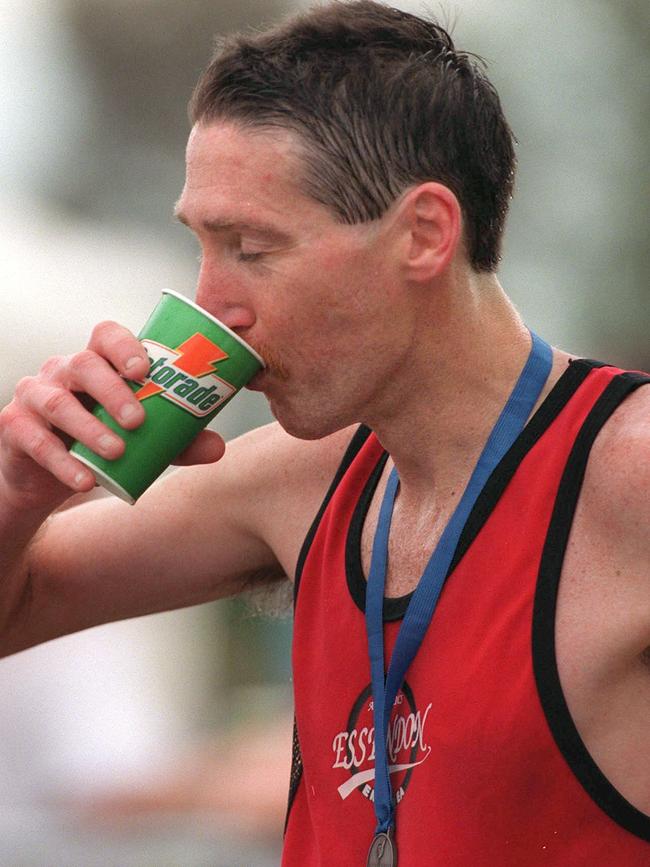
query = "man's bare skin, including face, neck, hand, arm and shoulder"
xmin=0 ymin=124 xmax=650 ymax=813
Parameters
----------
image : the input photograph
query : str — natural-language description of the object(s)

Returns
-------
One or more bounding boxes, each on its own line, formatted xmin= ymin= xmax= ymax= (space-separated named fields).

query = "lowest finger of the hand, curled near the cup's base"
xmin=6 ymin=413 xmax=95 ymax=491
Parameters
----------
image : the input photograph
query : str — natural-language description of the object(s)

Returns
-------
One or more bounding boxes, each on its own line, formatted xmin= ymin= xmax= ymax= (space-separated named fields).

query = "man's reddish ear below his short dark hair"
xmin=399 ymin=181 xmax=462 ymax=283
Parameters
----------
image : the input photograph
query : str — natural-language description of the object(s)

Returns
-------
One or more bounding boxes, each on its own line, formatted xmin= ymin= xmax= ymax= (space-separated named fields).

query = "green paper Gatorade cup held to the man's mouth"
xmin=70 ymin=289 xmax=264 ymax=503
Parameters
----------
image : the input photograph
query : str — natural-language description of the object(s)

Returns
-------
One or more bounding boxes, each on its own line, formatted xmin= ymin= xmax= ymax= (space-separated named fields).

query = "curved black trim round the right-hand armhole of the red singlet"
xmin=532 ymin=373 xmax=650 ymax=840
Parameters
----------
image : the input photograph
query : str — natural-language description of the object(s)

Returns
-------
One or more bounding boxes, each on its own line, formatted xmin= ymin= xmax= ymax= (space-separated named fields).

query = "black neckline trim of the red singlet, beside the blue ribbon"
xmin=345 ymin=359 xmax=592 ymax=621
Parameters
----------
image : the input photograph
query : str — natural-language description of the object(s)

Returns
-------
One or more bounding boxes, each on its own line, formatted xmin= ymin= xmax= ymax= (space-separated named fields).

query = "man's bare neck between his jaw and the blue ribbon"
xmin=367 ymin=275 xmax=569 ymax=503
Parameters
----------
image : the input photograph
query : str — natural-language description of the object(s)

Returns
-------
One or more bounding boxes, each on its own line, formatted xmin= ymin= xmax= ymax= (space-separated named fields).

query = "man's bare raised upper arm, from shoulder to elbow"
xmin=19 ymin=424 xmax=351 ymax=646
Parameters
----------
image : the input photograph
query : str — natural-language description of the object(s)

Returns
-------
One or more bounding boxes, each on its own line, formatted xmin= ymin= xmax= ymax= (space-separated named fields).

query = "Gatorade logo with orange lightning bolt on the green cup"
xmin=135 ymin=333 xmax=237 ymax=418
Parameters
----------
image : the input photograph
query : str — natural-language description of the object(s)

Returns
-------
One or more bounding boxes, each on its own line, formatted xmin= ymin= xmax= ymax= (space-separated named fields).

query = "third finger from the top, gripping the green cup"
xmin=21 ymin=382 xmax=129 ymax=460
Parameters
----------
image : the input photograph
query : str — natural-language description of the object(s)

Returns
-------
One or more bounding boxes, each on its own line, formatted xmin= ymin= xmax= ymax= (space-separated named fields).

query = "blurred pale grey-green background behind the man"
xmin=0 ymin=0 xmax=650 ymax=867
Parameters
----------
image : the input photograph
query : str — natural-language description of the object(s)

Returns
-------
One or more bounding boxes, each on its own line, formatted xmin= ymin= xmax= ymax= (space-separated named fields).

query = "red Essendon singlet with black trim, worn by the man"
xmin=283 ymin=361 xmax=650 ymax=867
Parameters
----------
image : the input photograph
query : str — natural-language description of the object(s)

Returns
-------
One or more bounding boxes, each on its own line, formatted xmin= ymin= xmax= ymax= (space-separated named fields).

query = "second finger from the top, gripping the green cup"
xmin=63 ymin=349 xmax=145 ymax=430
